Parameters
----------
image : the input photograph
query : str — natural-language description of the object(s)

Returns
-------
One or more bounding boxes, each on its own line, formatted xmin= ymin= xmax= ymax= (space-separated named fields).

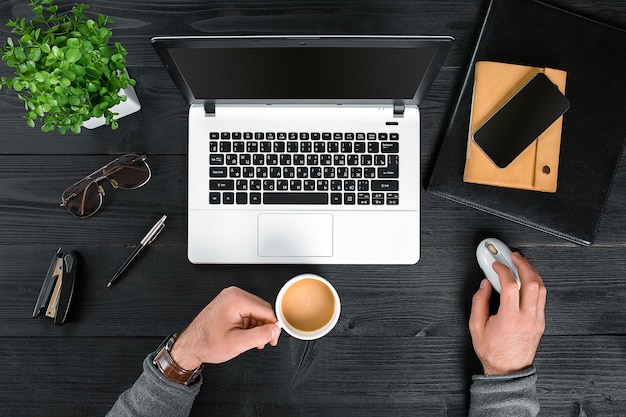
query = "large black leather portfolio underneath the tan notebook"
xmin=428 ymin=0 xmax=626 ymax=245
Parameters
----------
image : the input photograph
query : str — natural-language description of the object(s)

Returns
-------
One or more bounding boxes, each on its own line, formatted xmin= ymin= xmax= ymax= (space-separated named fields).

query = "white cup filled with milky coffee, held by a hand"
xmin=275 ymin=273 xmax=341 ymax=340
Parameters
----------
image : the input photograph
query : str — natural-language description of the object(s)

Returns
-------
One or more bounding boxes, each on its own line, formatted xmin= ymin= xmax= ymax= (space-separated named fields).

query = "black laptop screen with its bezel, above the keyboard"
xmin=153 ymin=37 xmax=450 ymax=104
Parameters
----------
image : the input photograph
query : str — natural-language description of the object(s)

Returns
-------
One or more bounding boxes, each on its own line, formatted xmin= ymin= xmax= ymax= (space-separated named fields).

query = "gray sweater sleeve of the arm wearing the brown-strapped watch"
xmin=107 ymin=353 xmax=202 ymax=417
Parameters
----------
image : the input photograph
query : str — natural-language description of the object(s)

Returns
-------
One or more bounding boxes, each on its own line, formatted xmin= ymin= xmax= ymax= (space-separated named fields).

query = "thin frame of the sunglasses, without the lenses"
xmin=61 ymin=153 xmax=152 ymax=219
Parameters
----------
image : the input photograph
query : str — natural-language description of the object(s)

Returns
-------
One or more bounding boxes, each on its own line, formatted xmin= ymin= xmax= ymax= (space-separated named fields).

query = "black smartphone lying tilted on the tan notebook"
xmin=473 ymin=73 xmax=569 ymax=168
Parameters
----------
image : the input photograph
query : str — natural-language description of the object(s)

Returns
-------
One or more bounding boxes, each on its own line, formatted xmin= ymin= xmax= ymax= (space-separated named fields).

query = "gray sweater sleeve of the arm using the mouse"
xmin=469 ymin=366 xmax=539 ymax=417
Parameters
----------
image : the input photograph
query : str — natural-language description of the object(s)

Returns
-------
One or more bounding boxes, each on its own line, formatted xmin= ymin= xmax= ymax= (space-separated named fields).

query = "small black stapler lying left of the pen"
xmin=33 ymin=248 xmax=78 ymax=324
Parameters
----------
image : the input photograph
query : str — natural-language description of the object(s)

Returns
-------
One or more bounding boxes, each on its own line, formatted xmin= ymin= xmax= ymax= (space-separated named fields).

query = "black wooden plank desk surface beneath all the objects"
xmin=0 ymin=0 xmax=626 ymax=417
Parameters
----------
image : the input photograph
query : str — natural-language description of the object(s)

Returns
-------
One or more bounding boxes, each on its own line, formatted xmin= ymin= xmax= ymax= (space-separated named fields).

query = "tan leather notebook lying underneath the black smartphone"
xmin=463 ymin=61 xmax=567 ymax=193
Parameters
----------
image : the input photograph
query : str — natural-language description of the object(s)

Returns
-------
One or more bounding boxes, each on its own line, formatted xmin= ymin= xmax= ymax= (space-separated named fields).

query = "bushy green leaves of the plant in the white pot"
xmin=0 ymin=0 xmax=135 ymax=133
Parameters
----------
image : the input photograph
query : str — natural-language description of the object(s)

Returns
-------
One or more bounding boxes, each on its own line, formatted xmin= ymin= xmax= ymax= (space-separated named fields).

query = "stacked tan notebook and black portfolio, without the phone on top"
xmin=428 ymin=0 xmax=626 ymax=245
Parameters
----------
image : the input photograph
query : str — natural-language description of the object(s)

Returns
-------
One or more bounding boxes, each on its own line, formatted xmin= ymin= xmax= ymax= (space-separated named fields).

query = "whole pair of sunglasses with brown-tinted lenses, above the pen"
xmin=61 ymin=153 xmax=152 ymax=218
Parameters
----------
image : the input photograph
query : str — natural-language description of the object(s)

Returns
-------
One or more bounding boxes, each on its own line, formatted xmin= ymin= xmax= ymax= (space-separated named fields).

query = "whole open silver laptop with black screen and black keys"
xmin=152 ymin=36 xmax=453 ymax=264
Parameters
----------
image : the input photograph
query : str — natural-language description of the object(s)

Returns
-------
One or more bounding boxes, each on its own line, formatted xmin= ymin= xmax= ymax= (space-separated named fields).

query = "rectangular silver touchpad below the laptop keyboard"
xmin=258 ymin=213 xmax=333 ymax=256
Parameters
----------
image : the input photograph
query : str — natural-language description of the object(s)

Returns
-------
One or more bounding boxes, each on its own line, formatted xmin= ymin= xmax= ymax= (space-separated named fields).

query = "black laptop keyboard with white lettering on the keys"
xmin=209 ymin=132 xmax=400 ymax=205
